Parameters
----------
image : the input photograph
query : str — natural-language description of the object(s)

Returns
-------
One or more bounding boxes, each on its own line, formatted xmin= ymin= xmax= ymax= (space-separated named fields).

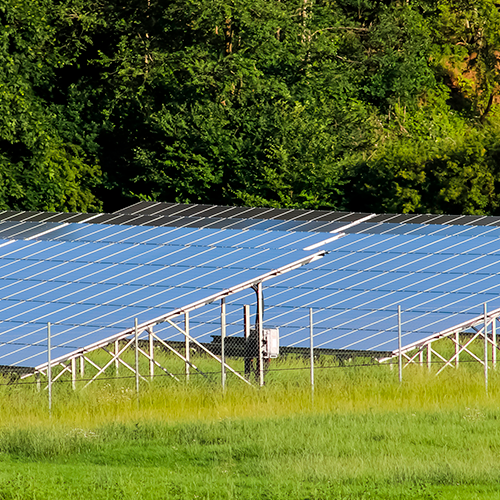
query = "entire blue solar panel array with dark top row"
xmin=0 ymin=202 xmax=500 ymax=366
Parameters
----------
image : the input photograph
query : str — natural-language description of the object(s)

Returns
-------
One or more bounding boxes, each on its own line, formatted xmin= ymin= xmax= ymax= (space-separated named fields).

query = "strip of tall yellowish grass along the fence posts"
xmin=0 ymin=359 xmax=500 ymax=428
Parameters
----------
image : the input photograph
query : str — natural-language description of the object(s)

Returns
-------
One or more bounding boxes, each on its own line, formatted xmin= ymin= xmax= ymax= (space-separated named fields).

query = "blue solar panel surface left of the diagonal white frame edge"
xmin=0 ymin=222 xmax=336 ymax=366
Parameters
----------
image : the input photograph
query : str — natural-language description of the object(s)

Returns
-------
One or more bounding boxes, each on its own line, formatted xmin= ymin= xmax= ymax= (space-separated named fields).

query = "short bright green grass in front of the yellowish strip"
xmin=0 ymin=408 xmax=500 ymax=500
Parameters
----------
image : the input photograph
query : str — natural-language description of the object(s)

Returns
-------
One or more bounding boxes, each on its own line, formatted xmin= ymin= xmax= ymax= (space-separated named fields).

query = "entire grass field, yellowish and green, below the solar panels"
xmin=0 ymin=348 xmax=500 ymax=500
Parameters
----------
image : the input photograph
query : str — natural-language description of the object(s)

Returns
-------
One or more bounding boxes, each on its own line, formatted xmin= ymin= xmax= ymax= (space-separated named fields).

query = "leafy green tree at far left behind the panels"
xmin=0 ymin=0 xmax=100 ymax=211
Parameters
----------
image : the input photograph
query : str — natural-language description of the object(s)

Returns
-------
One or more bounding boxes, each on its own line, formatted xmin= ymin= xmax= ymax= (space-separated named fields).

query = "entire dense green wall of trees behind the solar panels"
xmin=0 ymin=0 xmax=500 ymax=214
